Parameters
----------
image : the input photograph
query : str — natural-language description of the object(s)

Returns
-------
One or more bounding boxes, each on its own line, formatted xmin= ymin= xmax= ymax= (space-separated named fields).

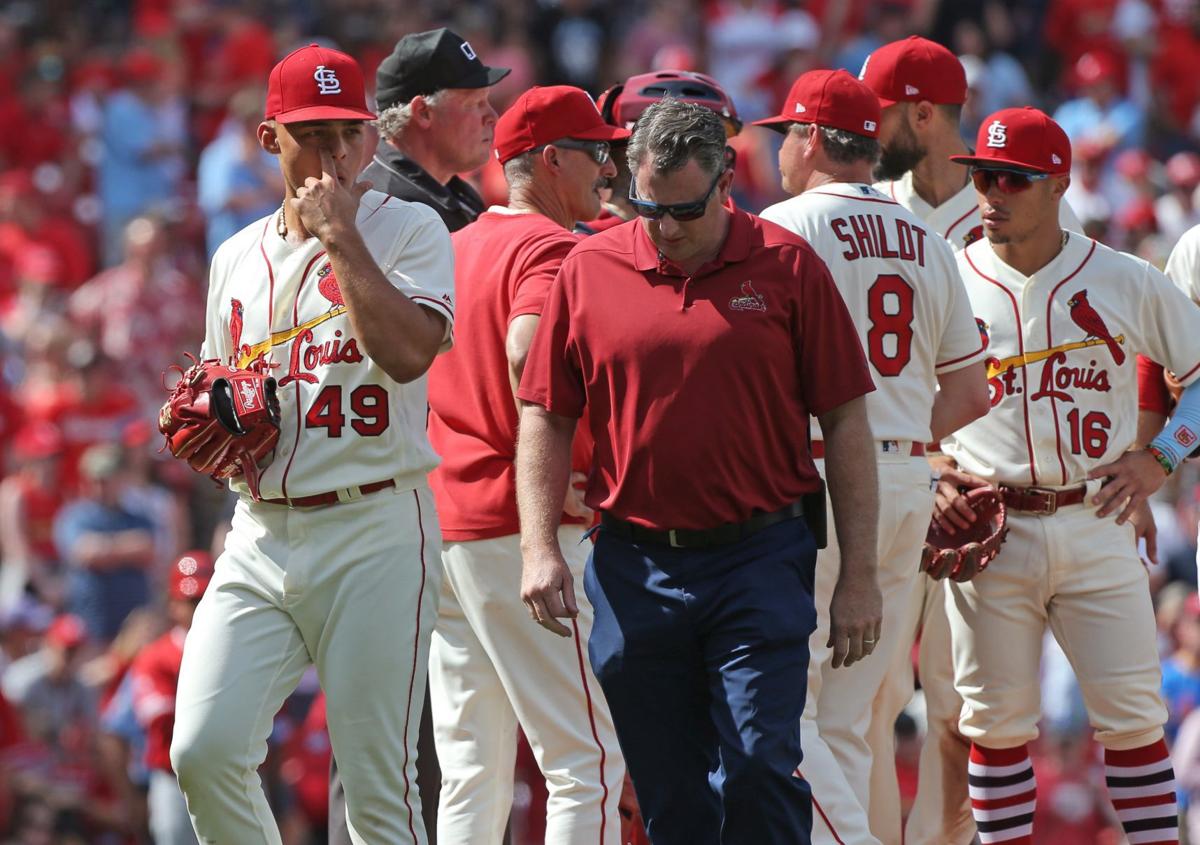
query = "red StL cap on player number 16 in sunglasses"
xmin=950 ymin=106 xmax=1070 ymax=175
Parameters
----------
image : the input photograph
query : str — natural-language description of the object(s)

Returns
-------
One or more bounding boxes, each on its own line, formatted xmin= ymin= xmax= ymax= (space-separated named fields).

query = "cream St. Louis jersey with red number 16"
xmin=942 ymin=234 xmax=1200 ymax=486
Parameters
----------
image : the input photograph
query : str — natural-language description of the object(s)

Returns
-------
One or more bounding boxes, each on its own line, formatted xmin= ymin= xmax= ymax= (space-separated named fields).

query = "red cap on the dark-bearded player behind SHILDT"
xmin=858 ymin=35 xmax=967 ymax=108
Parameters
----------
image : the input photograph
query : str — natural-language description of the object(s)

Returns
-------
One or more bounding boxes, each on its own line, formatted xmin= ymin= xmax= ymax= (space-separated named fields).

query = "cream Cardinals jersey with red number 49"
xmin=202 ymin=191 xmax=454 ymax=498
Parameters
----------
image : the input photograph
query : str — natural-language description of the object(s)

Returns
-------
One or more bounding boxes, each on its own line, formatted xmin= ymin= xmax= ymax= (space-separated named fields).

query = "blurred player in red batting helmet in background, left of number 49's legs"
xmin=130 ymin=551 xmax=212 ymax=845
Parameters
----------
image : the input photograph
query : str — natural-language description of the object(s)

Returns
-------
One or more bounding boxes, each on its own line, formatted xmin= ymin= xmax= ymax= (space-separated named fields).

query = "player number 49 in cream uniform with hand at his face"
xmin=170 ymin=44 xmax=454 ymax=843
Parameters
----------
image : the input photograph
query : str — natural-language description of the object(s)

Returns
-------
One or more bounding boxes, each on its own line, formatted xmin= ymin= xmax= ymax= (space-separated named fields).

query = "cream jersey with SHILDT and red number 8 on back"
xmin=762 ymin=182 xmax=984 ymax=443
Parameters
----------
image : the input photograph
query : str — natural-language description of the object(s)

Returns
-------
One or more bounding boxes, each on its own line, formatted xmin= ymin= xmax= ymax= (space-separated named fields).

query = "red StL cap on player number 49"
xmin=265 ymin=44 xmax=374 ymax=124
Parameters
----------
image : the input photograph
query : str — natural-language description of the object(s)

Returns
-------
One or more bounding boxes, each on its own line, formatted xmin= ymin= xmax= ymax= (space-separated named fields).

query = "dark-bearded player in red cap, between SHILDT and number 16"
xmin=859 ymin=36 xmax=1082 ymax=845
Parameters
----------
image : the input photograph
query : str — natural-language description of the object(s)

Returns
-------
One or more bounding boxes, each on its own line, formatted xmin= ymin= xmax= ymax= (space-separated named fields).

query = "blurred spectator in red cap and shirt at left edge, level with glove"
xmin=0 ymin=423 xmax=64 ymax=610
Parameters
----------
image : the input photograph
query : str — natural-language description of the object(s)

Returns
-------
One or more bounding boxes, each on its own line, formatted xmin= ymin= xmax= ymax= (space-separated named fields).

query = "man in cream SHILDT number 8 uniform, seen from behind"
xmin=756 ymin=71 xmax=988 ymax=843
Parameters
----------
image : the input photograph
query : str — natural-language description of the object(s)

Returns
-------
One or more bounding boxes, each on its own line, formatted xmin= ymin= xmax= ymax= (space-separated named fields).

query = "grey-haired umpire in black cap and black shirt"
xmin=362 ymin=29 xmax=509 ymax=232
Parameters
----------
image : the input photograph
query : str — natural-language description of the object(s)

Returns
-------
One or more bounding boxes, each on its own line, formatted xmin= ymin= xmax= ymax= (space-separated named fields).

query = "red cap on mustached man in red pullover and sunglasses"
xmin=494 ymin=85 xmax=631 ymax=164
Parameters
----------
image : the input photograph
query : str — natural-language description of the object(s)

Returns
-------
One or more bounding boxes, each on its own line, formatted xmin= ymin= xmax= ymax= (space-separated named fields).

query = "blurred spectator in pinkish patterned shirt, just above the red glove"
xmin=67 ymin=217 xmax=204 ymax=412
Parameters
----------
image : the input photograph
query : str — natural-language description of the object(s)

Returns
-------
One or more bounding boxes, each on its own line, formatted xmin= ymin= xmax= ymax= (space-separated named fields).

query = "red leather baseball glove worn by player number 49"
xmin=158 ymin=355 xmax=280 ymax=502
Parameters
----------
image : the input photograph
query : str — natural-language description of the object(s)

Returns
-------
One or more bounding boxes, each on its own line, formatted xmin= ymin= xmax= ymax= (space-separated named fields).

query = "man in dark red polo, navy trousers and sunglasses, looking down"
xmin=517 ymin=100 xmax=882 ymax=845
